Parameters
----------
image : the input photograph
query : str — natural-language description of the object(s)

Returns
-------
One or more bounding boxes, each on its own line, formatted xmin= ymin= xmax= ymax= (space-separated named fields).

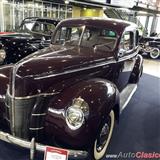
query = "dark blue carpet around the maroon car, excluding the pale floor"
xmin=0 ymin=74 xmax=160 ymax=160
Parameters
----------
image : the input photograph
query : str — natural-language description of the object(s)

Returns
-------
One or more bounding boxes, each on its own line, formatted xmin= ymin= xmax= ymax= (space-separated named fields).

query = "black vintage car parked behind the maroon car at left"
xmin=0 ymin=17 xmax=59 ymax=64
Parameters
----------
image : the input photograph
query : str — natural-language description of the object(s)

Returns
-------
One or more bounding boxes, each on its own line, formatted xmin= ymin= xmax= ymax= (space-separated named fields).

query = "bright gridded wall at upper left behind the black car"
xmin=0 ymin=0 xmax=72 ymax=31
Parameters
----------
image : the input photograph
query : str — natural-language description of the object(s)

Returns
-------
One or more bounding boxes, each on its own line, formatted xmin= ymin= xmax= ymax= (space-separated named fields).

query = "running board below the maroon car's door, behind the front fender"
xmin=120 ymin=84 xmax=137 ymax=113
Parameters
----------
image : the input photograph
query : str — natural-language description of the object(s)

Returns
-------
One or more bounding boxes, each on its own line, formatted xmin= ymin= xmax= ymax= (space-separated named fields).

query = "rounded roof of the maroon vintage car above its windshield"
xmin=59 ymin=17 xmax=137 ymax=34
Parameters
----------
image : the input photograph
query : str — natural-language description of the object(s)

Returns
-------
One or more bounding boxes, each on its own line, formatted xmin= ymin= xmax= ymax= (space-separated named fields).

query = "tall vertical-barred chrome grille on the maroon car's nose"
xmin=5 ymin=95 xmax=36 ymax=139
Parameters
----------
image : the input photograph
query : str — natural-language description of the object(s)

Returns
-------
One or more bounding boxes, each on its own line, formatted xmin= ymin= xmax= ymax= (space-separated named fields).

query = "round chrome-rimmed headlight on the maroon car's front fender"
xmin=65 ymin=97 xmax=89 ymax=130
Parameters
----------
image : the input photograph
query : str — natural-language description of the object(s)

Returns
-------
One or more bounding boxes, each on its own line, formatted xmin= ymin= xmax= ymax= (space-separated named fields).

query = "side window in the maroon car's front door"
xmin=120 ymin=32 xmax=134 ymax=51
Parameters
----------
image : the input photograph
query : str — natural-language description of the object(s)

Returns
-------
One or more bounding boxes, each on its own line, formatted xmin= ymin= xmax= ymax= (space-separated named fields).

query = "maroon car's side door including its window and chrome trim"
xmin=116 ymin=30 xmax=138 ymax=91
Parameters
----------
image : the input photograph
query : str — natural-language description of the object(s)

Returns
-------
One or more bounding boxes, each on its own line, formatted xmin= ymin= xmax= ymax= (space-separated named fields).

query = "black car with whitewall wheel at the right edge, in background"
xmin=139 ymin=36 xmax=160 ymax=59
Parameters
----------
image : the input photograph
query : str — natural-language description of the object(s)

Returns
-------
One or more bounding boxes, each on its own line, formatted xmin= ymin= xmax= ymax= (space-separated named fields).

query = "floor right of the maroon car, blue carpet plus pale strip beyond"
xmin=103 ymin=59 xmax=160 ymax=160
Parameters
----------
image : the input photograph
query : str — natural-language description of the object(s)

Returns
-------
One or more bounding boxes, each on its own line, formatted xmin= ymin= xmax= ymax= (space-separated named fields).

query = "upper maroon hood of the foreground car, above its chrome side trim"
xmin=16 ymin=46 xmax=113 ymax=77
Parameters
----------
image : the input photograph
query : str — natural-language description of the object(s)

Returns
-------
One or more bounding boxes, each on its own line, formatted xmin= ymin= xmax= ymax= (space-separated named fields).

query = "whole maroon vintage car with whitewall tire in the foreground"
xmin=0 ymin=18 xmax=143 ymax=160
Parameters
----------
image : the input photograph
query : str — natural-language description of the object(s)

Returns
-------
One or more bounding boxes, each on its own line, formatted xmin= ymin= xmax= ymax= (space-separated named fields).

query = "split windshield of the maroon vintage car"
xmin=53 ymin=26 xmax=117 ymax=51
